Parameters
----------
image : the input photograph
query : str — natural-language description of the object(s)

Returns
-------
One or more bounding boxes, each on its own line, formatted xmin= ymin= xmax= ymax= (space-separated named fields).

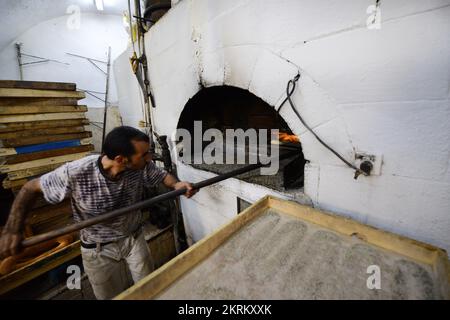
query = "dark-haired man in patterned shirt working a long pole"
xmin=0 ymin=126 xmax=196 ymax=299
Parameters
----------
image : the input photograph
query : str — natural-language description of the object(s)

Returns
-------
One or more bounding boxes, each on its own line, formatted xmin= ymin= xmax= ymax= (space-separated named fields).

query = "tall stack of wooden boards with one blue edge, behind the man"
xmin=0 ymin=81 xmax=94 ymax=292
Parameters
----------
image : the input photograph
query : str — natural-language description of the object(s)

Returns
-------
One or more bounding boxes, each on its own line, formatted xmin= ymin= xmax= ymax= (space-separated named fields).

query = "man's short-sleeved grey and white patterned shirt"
xmin=40 ymin=155 xmax=167 ymax=243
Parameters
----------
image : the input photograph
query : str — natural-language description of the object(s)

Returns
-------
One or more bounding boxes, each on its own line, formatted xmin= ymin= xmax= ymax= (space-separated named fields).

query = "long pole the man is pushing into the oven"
xmin=21 ymin=150 xmax=298 ymax=247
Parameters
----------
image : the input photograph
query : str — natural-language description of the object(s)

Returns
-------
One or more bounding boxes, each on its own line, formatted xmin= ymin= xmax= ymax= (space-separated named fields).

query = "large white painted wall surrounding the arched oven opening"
xmin=117 ymin=0 xmax=450 ymax=254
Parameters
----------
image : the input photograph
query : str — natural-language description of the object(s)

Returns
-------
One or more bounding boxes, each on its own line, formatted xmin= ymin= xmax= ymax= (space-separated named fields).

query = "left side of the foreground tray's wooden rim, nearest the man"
xmin=114 ymin=196 xmax=269 ymax=300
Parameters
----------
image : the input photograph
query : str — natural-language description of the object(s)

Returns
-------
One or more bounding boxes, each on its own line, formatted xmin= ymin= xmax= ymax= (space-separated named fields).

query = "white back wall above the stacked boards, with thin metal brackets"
xmin=0 ymin=13 xmax=128 ymax=107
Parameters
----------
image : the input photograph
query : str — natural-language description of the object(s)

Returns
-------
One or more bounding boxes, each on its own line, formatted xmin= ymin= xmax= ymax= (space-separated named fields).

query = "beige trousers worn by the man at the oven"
xmin=81 ymin=232 xmax=154 ymax=300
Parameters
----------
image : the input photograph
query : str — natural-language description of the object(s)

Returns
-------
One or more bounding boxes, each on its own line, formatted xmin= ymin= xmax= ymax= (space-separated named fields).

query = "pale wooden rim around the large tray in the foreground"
xmin=114 ymin=195 xmax=450 ymax=300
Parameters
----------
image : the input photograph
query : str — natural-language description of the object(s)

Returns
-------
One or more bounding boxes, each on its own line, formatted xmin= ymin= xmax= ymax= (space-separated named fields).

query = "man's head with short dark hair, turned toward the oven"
xmin=103 ymin=126 xmax=152 ymax=170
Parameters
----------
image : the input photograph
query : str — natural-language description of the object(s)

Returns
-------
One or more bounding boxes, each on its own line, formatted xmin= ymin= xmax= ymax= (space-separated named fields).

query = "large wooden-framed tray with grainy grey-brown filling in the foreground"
xmin=116 ymin=196 xmax=450 ymax=300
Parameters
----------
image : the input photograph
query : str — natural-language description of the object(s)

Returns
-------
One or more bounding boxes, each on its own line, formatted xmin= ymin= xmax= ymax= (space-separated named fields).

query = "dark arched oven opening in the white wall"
xmin=178 ymin=86 xmax=306 ymax=191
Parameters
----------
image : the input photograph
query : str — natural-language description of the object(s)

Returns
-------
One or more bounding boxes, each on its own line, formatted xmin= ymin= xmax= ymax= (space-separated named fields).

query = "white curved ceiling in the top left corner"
xmin=0 ymin=0 xmax=130 ymax=51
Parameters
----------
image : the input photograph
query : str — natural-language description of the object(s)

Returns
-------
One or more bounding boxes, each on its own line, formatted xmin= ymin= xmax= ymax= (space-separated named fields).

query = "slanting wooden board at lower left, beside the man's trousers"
xmin=0 ymin=241 xmax=80 ymax=295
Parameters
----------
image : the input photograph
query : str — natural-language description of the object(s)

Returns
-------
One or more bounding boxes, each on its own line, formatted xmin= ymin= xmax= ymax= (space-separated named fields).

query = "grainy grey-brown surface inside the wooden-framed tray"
xmin=158 ymin=209 xmax=442 ymax=299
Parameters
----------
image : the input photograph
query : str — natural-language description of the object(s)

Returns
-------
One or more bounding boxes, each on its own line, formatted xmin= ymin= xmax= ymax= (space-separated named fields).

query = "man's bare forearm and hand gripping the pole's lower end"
xmin=0 ymin=179 xmax=42 ymax=259
